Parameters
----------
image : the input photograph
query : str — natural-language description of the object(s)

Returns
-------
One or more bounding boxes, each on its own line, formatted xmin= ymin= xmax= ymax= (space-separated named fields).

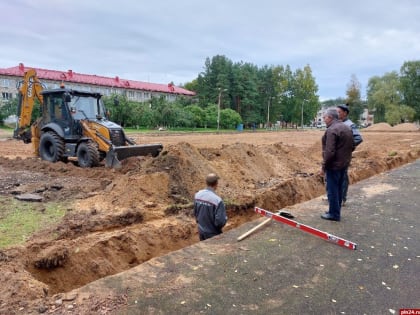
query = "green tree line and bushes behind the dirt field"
xmin=0 ymin=55 xmax=420 ymax=129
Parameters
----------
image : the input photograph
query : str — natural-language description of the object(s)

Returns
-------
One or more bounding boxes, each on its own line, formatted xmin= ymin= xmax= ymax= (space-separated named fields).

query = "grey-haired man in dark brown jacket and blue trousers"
xmin=320 ymin=108 xmax=354 ymax=221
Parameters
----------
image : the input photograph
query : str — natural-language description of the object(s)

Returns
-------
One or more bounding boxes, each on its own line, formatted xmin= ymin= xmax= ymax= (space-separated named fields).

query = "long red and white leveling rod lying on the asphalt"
xmin=255 ymin=207 xmax=357 ymax=250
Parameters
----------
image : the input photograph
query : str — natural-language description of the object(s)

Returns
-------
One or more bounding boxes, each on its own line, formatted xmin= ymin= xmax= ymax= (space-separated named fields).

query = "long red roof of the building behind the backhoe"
xmin=0 ymin=63 xmax=195 ymax=96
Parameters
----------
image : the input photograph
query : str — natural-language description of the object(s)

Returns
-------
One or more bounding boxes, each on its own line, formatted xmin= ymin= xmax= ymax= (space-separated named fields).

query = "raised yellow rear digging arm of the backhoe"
xmin=13 ymin=69 xmax=43 ymax=143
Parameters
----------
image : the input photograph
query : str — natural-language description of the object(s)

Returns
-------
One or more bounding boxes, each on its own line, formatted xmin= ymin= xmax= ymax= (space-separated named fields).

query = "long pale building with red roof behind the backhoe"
xmin=0 ymin=63 xmax=195 ymax=102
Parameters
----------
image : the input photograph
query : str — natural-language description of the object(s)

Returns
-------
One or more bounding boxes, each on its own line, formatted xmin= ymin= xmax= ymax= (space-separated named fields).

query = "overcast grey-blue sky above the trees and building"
xmin=0 ymin=0 xmax=420 ymax=100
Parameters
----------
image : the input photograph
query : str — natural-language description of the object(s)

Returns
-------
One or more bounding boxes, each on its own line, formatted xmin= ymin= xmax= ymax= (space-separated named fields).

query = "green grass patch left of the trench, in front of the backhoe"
xmin=0 ymin=196 xmax=66 ymax=249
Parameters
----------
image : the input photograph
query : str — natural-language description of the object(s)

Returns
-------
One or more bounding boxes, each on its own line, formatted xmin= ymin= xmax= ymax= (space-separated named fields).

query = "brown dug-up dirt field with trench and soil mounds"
xmin=0 ymin=124 xmax=420 ymax=314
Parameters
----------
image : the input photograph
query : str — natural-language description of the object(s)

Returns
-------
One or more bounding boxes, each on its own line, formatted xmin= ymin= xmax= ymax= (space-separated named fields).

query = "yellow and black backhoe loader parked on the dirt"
xmin=13 ymin=69 xmax=163 ymax=168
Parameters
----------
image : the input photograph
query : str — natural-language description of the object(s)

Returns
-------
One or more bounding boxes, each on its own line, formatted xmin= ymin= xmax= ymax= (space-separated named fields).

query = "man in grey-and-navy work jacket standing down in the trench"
xmin=194 ymin=173 xmax=227 ymax=241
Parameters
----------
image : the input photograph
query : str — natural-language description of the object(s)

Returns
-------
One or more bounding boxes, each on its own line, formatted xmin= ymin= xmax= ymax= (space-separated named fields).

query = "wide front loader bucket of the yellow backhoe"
xmin=105 ymin=143 xmax=163 ymax=169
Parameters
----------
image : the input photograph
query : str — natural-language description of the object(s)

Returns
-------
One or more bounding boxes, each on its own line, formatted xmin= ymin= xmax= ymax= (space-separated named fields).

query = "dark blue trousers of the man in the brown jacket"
xmin=326 ymin=168 xmax=347 ymax=220
